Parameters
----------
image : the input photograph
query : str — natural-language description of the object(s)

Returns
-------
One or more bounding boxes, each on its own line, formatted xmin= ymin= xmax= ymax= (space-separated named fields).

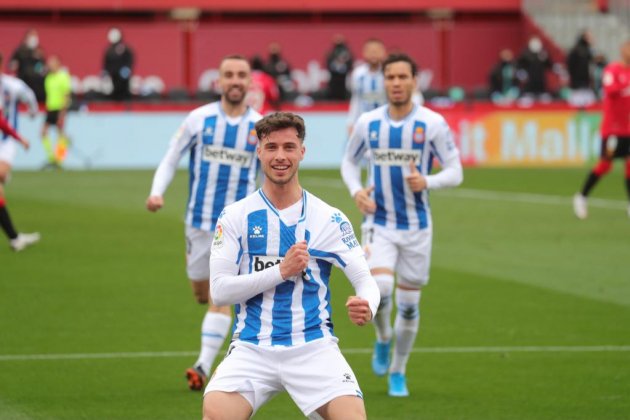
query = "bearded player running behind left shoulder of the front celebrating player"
xmin=146 ymin=56 xmax=261 ymax=390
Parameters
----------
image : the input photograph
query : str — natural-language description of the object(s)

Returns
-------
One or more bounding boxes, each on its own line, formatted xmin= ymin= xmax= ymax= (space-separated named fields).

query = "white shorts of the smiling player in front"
xmin=204 ymin=337 xmax=363 ymax=416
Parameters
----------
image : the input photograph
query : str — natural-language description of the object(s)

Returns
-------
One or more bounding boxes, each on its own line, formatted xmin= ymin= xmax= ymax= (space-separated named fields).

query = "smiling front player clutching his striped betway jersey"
xmin=204 ymin=112 xmax=379 ymax=420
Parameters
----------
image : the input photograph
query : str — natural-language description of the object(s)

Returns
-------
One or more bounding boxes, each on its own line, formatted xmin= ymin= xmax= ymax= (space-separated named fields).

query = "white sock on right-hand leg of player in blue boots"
xmin=389 ymin=289 xmax=420 ymax=374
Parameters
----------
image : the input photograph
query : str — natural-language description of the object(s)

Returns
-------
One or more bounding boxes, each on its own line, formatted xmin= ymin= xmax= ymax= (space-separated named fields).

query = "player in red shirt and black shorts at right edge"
xmin=573 ymin=40 xmax=630 ymax=219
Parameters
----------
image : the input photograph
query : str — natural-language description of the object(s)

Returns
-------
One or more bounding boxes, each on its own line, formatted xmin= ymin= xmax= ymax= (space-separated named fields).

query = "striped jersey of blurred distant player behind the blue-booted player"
xmin=348 ymin=63 xmax=387 ymax=126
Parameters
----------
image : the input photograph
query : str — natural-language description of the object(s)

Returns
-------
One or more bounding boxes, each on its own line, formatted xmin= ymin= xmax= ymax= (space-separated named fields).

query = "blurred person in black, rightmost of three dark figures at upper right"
xmin=567 ymin=31 xmax=595 ymax=106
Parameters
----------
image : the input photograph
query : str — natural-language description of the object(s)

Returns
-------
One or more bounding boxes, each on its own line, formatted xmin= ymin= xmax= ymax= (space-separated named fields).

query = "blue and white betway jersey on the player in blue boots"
xmin=342 ymin=105 xmax=463 ymax=230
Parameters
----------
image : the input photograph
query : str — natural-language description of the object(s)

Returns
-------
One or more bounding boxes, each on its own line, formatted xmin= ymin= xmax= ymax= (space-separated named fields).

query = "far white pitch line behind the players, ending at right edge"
xmin=304 ymin=177 xmax=628 ymax=210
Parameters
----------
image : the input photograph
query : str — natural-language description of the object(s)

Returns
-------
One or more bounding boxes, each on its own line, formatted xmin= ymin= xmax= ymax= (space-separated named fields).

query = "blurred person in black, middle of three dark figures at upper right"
xmin=517 ymin=36 xmax=553 ymax=98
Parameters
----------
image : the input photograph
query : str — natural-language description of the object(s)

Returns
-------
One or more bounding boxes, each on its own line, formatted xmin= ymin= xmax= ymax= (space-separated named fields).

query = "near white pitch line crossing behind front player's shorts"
xmin=0 ymin=345 xmax=630 ymax=362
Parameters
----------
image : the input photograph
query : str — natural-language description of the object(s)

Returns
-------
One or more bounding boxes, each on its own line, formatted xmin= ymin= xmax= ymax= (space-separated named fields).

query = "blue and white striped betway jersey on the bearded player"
xmin=151 ymin=102 xmax=262 ymax=231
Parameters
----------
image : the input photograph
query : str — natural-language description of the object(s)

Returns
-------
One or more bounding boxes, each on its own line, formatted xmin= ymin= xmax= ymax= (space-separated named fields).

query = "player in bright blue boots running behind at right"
xmin=341 ymin=54 xmax=463 ymax=397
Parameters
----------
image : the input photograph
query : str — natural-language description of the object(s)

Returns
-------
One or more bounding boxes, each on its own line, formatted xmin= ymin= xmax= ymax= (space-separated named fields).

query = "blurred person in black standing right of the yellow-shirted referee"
xmin=103 ymin=27 xmax=133 ymax=101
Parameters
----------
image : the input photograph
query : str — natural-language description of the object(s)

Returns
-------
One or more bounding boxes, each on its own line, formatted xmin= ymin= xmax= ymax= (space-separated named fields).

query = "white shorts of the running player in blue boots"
xmin=361 ymin=225 xmax=433 ymax=287
